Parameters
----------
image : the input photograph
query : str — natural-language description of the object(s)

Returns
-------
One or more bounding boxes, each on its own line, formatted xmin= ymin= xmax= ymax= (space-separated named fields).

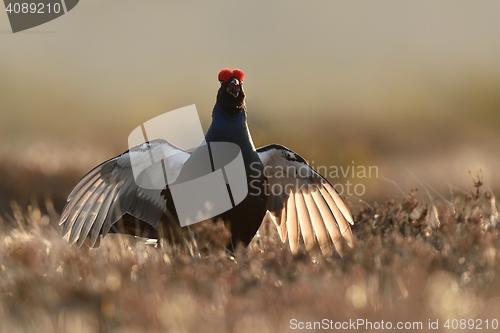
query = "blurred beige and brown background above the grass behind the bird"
xmin=0 ymin=0 xmax=500 ymax=213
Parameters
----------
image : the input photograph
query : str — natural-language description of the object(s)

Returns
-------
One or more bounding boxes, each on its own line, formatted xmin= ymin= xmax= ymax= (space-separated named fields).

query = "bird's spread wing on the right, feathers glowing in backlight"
xmin=257 ymin=144 xmax=353 ymax=255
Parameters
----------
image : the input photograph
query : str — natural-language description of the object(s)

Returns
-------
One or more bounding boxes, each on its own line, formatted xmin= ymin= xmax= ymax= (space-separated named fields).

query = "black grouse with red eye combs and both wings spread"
xmin=59 ymin=68 xmax=354 ymax=255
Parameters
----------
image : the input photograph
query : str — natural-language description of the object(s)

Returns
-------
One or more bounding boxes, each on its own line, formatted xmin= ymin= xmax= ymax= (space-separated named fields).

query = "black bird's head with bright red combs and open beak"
xmin=217 ymin=68 xmax=245 ymax=112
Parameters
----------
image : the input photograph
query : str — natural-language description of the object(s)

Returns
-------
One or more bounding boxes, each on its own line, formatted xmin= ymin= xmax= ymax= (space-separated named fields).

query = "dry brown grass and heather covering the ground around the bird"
xmin=0 ymin=178 xmax=500 ymax=332
